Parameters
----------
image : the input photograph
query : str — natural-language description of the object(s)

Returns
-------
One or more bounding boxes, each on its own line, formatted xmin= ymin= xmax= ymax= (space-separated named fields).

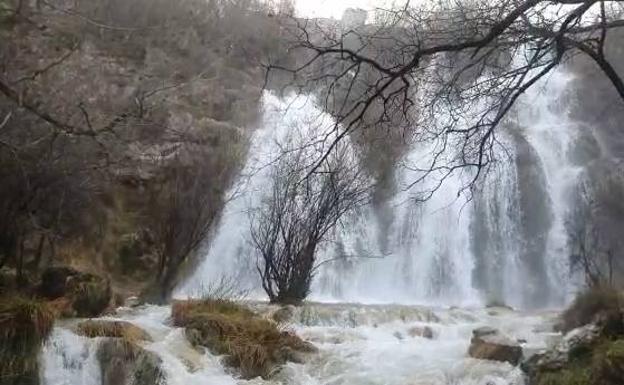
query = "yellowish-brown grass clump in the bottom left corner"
xmin=0 ymin=297 xmax=54 ymax=383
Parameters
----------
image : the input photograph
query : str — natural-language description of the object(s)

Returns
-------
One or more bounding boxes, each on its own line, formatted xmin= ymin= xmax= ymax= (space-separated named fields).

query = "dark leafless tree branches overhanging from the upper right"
xmin=267 ymin=0 xmax=624 ymax=198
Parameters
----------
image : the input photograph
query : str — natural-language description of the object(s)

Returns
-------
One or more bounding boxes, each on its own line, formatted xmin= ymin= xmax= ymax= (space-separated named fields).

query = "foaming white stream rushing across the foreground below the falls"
xmin=42 ymin=304 xmax=557 ymax=385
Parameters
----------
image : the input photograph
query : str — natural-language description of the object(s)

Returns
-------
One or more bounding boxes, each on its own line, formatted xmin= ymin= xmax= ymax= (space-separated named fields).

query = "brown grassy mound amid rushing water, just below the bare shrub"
xmin=172 ymin=299 xmax=316 ymax=379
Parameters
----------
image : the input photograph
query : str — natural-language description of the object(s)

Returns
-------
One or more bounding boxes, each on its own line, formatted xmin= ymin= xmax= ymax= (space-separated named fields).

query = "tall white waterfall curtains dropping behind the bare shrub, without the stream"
xmin=176 ymin=67 xmax=582 ymax=307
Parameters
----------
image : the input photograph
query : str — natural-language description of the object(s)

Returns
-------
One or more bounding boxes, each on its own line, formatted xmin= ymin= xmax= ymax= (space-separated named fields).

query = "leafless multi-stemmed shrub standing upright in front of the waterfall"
xmin=250 ymin=134 xmax=369 ymax=304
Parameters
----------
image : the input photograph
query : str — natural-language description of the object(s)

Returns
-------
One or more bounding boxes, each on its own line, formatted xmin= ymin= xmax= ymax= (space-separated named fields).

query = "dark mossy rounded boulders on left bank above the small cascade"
xmin=39 ymin=267 xmax=112 ymax=317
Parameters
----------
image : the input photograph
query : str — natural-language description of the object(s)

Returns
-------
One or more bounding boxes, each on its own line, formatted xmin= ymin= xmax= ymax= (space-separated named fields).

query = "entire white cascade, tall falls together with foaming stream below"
xmin=41 ymin=67 xmax=581 ymax=385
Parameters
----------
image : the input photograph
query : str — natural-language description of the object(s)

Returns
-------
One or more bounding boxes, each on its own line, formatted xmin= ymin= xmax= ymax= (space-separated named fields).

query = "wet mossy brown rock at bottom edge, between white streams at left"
xmin=97 ymin=338 xmax=165 ymax=385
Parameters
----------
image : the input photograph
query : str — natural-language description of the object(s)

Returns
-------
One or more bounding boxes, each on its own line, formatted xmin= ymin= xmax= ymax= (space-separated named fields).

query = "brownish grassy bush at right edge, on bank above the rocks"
xmin=559 ymin=286 xmax=624 ymax=334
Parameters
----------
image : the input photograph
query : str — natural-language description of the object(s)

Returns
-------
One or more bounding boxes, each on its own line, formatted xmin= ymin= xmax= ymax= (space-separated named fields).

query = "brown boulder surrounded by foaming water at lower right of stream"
xmin=468 ymin=326 xmax=522 ymax=365
